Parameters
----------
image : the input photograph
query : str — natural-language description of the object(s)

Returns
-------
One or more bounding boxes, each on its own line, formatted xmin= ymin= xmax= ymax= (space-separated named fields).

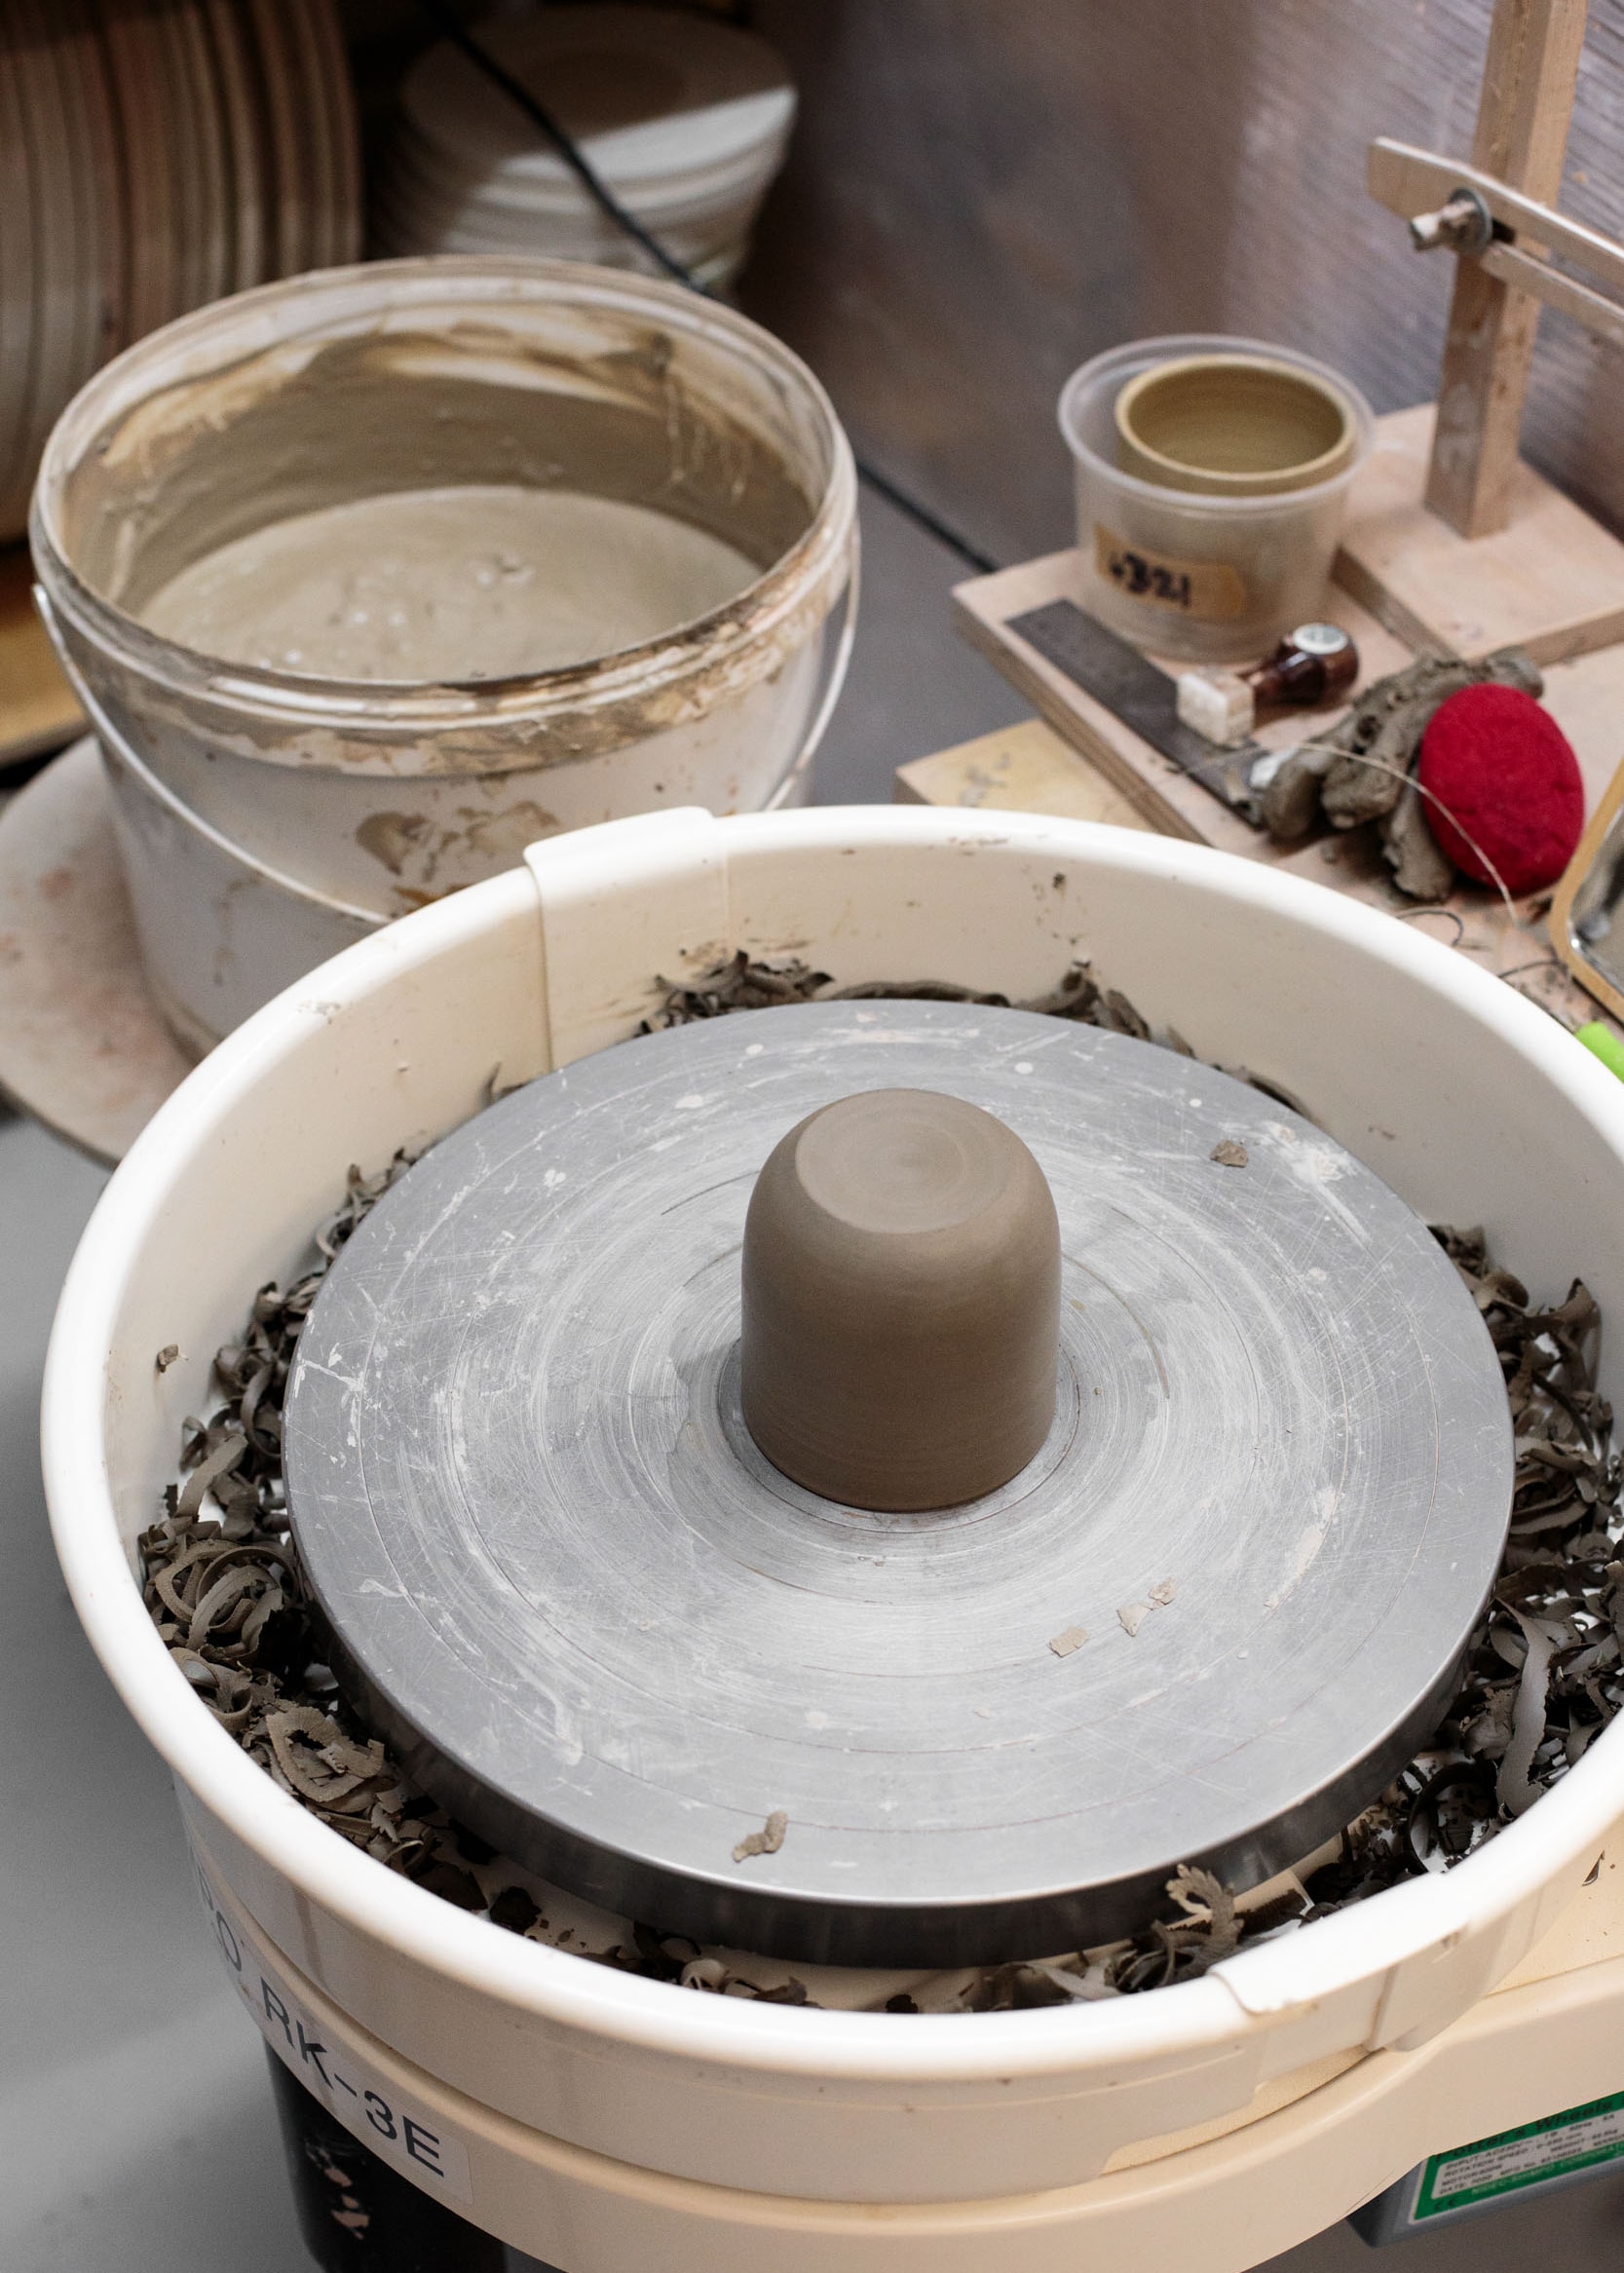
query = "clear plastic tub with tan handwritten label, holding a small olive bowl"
xmin=1061 ymin=332 xmax=1375 ymax=663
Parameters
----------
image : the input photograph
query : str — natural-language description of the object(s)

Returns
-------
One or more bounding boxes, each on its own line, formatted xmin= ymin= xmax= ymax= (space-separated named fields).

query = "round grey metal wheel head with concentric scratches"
xmin=286 ymin=1003 xmax=1513 ymax=1964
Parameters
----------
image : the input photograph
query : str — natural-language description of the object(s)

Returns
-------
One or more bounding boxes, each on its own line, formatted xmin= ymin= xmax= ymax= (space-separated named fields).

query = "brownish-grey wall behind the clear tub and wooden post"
xmin=745 ymin=0 xmax=1624 ymax=559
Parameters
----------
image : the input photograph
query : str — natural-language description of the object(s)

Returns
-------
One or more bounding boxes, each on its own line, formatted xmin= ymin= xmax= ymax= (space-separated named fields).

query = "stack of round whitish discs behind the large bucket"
xmin=372 ymin=5 xmax=795 ymax=286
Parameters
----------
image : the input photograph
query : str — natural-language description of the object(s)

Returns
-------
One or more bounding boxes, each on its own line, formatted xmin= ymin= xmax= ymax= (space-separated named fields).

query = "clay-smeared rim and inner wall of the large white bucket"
xmin=36 ymin=261 xmax=854 ymax=776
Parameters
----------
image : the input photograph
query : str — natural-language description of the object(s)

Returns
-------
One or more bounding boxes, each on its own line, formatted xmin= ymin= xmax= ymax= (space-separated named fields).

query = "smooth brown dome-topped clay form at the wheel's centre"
xmin=740 ymin=1089 xmax=1061 ymax=1509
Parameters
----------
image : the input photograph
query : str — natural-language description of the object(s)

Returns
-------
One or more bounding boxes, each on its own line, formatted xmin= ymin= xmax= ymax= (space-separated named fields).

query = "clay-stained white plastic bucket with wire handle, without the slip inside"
xmin=32 ymin=259 xmax=856 ymax=1045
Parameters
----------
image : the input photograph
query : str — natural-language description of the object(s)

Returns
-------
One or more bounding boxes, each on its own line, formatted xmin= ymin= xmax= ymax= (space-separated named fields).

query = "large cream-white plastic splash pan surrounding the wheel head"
xmin=43 ymin=807 xmax=1624 ymax=2273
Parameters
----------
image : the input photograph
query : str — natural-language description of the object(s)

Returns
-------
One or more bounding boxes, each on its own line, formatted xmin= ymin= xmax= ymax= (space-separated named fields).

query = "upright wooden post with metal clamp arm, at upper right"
xmin=1426 ymin=0 xmax=1585 ymax=537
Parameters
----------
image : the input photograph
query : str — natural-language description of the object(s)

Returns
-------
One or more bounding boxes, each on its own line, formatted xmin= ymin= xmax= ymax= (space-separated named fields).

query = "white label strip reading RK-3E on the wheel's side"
xmin=191 ymin=1848 xmax=476 ymax=2200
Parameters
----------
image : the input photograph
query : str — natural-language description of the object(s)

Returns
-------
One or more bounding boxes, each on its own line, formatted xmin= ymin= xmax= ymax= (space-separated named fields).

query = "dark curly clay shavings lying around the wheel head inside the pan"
xmin=141 ymin=953 xmax=1624 ymax=2012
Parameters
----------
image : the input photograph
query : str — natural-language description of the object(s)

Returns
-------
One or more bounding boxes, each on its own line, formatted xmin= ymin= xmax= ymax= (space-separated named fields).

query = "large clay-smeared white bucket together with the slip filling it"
xmin=32 ymin=259 xmax=856 ymax=1050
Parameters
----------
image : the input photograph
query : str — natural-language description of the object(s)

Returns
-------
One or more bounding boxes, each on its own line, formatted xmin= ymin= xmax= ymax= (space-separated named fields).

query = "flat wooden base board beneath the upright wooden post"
xmin=1334 ymin=402 xmax=1624 ymax=663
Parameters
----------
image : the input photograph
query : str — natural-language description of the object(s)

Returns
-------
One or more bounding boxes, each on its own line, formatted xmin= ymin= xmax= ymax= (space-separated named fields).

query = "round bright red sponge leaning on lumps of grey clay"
xmin=1417 ymin=687 xmax=1585 ymax=895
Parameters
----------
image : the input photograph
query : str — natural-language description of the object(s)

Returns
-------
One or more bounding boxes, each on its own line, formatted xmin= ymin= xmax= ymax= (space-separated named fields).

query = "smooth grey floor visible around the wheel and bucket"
xmin=0 ymin=488 xmax=1624 ymax=2273
